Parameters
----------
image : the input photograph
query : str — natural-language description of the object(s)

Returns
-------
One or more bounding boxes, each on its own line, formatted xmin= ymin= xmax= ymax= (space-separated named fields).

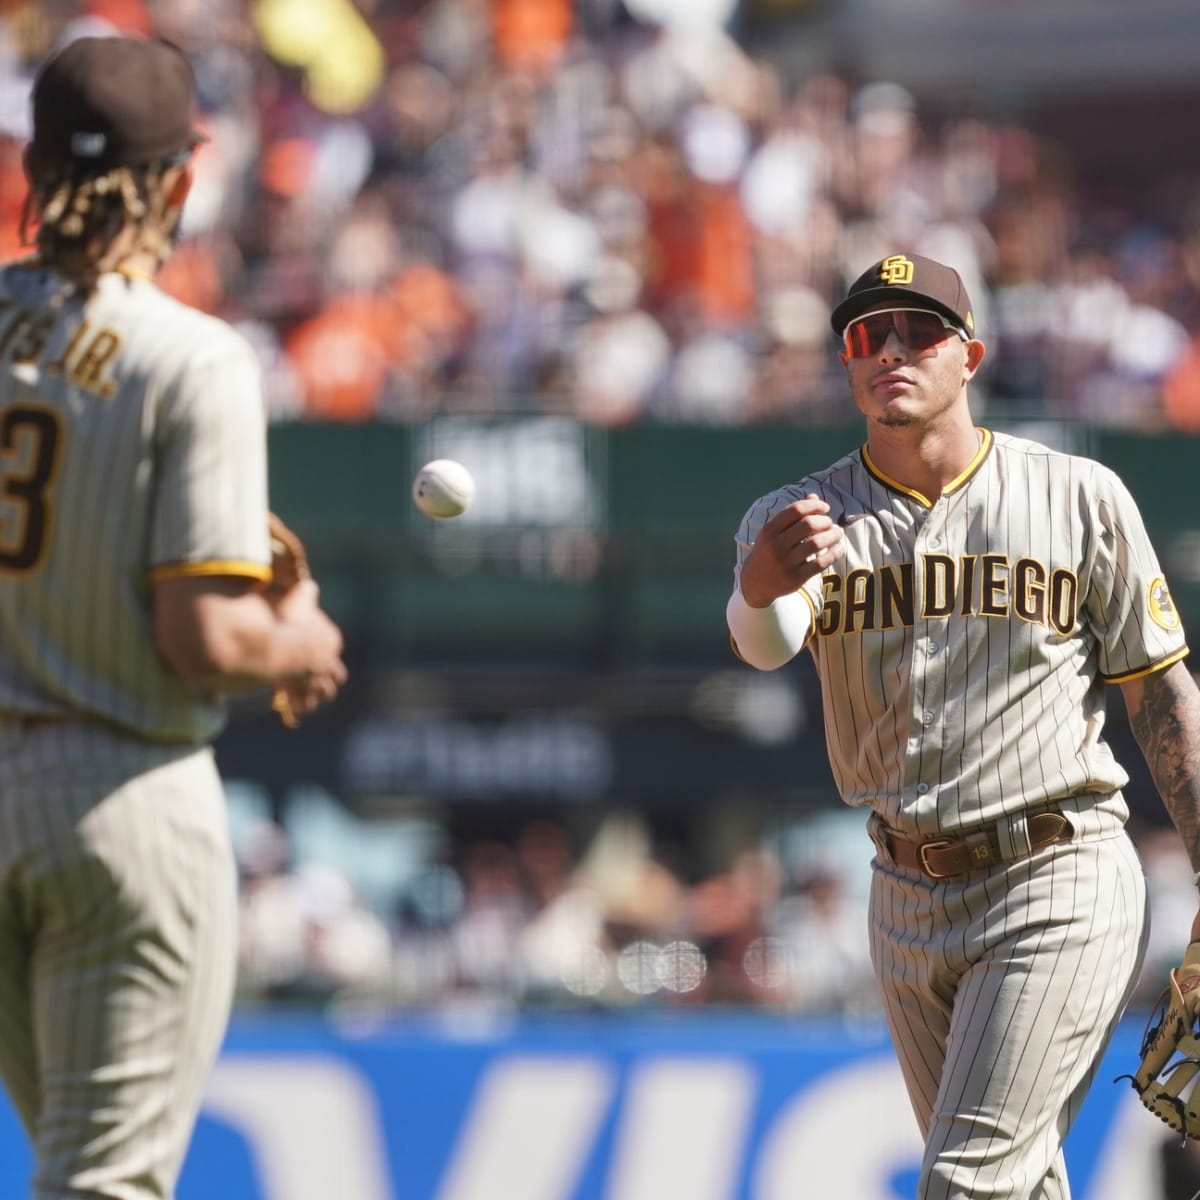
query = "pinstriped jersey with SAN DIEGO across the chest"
xmin=737 ymin=431 xmax=1187 ymax=836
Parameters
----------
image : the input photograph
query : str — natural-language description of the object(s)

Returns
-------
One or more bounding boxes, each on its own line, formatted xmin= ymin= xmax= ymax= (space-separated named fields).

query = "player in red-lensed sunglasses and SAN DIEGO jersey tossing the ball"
xmin=727 ymin=254 xmax=1200 ymax=1200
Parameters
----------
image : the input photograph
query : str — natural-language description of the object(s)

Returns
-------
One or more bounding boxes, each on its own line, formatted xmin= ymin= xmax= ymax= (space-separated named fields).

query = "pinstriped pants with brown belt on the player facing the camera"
xmin=870 ymin=832 xmax=1147 ymax=1200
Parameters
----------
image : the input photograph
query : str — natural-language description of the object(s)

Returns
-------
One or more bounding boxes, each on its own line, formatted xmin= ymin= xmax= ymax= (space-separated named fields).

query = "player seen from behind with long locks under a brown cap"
xmin=0 ymin=37 xmax=346 ymax=1200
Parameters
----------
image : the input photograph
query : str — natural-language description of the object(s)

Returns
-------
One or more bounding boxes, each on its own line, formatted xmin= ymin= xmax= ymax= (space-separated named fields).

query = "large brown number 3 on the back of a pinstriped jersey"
xmin=0 ymin=404 xmax=62 ymax=575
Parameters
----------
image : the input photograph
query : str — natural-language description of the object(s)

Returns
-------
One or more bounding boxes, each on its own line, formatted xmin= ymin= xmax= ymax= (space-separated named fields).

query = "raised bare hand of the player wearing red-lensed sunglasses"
xmin=740 ymin=496 xmax=846 ymax=608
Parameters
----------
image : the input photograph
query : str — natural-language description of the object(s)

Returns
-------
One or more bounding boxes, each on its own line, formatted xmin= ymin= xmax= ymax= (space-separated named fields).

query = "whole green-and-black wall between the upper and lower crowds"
xmin=208 ymin=418 xmax=1200 ymax=811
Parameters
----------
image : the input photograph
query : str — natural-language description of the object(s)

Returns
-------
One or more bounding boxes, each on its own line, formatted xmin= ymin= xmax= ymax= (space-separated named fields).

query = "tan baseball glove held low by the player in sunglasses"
xmin=1117 ymin=942 xmax=1200 ymax=1138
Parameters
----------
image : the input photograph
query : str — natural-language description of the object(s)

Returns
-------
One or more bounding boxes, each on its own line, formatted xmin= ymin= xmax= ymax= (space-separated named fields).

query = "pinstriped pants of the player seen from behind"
xmin=0 ymin=722 xmax=236 ymax=1200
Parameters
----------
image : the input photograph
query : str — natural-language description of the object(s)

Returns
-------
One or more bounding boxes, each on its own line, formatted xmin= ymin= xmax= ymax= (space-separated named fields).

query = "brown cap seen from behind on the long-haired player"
xmin=31 ymin=36 xmax=204 ymax=172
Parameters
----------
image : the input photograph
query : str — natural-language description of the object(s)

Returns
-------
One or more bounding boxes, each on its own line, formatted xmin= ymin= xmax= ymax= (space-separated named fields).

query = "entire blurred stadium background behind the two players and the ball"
xmin=7 ymin=0 xmax=1200 ymax=1200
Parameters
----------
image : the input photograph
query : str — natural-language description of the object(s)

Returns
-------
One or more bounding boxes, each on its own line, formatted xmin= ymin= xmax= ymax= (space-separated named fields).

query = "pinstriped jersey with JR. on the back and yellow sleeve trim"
xmin=0 ymin=263 xmax=270 ymax=743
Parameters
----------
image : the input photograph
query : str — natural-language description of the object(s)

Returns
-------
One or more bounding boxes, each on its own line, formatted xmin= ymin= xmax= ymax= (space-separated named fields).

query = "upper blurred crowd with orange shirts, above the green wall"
xmin=7 ymin=0 xmax=1200 ymax=431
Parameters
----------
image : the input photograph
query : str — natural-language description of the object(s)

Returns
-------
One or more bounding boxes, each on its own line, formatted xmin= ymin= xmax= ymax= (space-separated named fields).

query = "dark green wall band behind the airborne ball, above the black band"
xmin=271 ymin=418 xmax=1200 ymax=666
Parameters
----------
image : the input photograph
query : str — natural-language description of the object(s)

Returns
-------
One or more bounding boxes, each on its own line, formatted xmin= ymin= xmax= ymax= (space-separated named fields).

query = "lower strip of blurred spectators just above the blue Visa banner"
xmin=226 ymin=793 xmax=1196 ymax=1021
